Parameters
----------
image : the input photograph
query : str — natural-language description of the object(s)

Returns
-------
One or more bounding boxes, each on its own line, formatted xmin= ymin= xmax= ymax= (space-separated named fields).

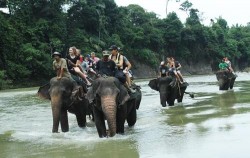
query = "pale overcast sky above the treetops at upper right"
xmin=115 ymin=0 xmax=250 ymax=26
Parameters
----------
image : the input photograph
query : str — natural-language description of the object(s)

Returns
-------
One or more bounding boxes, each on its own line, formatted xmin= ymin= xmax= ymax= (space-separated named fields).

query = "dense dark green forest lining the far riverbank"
xmin=0 ymin=0 xmax=250 ymax=89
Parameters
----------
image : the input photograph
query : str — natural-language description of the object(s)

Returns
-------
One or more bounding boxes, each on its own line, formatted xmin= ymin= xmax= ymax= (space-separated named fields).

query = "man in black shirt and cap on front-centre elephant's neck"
xmin=96 ymin=51 xmax=117 ymax=76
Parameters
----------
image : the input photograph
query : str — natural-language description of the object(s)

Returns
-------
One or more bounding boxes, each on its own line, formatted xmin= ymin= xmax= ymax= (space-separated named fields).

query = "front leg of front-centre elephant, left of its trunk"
xmin=93 ymin=107 xmax=107 ymax=138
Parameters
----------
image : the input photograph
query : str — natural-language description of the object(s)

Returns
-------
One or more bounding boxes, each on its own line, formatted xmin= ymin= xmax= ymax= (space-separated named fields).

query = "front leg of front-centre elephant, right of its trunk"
xmin=116 ymin=104 xmax=127 ymax=134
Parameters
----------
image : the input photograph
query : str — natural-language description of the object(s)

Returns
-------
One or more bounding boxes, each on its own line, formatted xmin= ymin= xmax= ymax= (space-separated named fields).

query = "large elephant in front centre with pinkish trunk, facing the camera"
xmin=86 ymin=77 xmax=141 ymax=138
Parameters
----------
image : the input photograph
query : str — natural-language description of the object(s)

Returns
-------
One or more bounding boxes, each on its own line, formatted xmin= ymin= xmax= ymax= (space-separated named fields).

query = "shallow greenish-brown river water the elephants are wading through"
xmin=0 ymin=73 xmax=250 ymax=158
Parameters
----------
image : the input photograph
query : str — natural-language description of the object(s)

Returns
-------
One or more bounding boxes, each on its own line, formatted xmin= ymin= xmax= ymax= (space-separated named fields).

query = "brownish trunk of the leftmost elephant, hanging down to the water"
xmin=51 ymin=96 xmax=62 ymax=133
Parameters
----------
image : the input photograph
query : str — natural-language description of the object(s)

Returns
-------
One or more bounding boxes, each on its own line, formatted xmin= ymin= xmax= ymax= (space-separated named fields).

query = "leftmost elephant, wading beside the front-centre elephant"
xmin=38 ymin=77 xmax=89 ymax=133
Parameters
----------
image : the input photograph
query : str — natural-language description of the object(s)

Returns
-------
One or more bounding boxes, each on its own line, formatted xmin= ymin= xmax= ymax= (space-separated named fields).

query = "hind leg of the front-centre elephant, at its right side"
xmin=127 ymin=100 xmax=137 ymax=127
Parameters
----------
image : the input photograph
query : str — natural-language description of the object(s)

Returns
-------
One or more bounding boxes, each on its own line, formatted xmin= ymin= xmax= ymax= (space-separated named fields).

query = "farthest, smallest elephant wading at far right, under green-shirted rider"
xmin=216 ymin=70 xmax=237 ymax=90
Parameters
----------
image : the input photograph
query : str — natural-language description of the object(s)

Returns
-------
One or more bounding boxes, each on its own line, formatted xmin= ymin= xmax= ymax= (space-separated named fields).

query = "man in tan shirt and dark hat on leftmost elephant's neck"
xmin=52 ymin=52 xmax=72 ymax=80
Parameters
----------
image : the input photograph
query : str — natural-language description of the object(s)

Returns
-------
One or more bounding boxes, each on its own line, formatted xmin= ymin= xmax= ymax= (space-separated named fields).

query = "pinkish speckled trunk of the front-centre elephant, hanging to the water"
xmin=101 ymin=96 xmax=117 ymax=137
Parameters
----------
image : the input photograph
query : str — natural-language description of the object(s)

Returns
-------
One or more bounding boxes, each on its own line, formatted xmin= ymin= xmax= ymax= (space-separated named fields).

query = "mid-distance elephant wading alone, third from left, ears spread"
xmin=148 ymin=76 xmax=188 ymax=107
